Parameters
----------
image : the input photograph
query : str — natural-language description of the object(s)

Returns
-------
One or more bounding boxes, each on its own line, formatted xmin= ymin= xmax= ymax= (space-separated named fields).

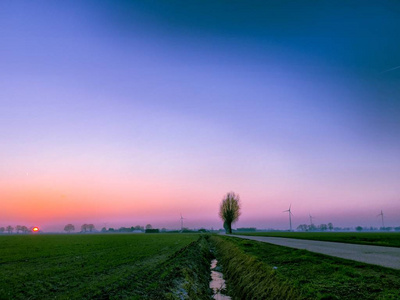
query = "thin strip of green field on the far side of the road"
xmin=236 ymin=232 xmax=400 ymax=247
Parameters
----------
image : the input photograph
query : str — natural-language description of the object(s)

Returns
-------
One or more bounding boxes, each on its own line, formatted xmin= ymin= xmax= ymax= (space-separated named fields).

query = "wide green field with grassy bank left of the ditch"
xmin=0 ymin=234 xmax=210 ymax=299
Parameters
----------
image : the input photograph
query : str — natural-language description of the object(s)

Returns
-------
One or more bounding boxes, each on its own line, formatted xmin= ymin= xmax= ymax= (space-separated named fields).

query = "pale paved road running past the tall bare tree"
xmin=231 ymin=235 xmax=400 ymax=270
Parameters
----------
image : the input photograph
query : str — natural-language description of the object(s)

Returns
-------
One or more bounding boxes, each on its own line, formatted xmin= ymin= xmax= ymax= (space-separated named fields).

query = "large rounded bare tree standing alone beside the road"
xmin=219 ymin=192 xmax=240 ymax=234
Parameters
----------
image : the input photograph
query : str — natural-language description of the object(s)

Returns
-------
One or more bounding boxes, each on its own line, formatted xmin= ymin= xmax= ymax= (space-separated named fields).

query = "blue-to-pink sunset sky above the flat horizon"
xmin=0 ymin=0 xmax=400 ymax=231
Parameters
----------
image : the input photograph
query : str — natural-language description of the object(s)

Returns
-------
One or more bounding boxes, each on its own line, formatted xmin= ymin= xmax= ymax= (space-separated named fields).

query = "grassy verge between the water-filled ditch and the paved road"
xmin=211 ymin=236 xmax=400 ymax=300
